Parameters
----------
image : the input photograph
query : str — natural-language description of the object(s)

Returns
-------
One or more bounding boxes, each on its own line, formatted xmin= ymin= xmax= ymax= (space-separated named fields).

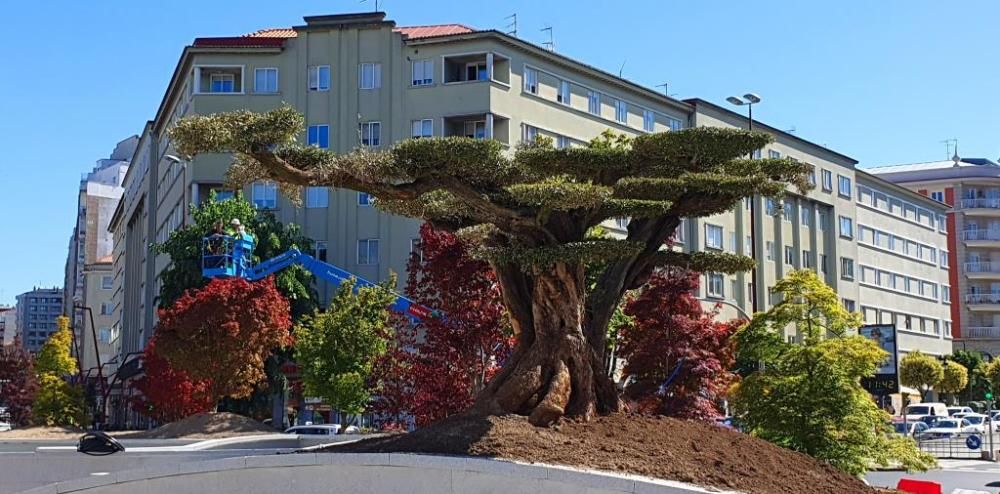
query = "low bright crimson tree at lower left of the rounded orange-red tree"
xmin=132 ymin=337 xmax=215 ymax=423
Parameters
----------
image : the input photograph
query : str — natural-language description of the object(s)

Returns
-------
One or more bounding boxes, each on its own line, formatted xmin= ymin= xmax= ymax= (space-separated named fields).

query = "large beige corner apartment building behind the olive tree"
xmin=110 ymin=8 xmax=951 ymax=424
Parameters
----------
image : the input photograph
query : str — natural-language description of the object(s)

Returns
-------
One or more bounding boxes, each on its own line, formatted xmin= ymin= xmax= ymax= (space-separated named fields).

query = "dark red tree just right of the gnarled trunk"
xmin=618 ymin=269 xmax=740 ymax=420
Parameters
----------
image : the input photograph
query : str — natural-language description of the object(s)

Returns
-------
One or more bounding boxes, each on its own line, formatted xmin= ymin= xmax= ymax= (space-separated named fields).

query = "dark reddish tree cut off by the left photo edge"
xmin=0 ymin=340 xmax=38 ymax=426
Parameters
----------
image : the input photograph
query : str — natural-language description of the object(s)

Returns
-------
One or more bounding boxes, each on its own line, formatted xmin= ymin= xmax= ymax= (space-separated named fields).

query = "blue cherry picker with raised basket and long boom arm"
xmin=201 ymin=231 xmax=440 ymax=323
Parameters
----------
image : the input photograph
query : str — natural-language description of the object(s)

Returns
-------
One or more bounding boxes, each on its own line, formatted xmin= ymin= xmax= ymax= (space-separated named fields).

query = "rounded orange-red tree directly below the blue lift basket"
xmin=156 ymin=277 xmax=292 ymax=403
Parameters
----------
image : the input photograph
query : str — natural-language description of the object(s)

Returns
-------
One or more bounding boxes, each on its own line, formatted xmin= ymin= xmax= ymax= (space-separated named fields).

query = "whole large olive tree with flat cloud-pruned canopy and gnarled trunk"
xmin=170 ymin=108 xmax=808 ymax=425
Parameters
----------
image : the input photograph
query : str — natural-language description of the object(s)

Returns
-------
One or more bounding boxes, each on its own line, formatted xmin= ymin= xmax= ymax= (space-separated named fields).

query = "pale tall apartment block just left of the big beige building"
xmin=63 ymin=136 xmax=139 ymax=375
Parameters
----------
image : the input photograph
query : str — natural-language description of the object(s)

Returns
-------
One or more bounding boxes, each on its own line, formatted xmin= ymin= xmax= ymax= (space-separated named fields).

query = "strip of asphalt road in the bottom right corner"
xmin=865 ymin=460 xmax=1000 ymax=494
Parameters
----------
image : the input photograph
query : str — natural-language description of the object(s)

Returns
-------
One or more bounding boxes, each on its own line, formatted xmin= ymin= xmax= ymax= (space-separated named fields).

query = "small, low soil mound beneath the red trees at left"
xmin=129 ymin=412 xmax=277 ymax=439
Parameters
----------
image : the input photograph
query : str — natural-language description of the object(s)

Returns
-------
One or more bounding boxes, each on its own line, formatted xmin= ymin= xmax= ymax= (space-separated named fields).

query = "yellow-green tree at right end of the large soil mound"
xmin=732 ymin=270 xmax=934 ymax=475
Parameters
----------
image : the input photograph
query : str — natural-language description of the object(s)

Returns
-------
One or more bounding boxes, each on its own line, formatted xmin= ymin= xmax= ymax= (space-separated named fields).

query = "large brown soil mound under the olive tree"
xmin=325 ymin=415 xmax=877 ymax=494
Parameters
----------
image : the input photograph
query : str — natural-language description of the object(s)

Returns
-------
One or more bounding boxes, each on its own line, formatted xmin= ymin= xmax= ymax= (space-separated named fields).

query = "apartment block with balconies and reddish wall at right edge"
xmin=870 ymin=155 xmax=1000 ymax=357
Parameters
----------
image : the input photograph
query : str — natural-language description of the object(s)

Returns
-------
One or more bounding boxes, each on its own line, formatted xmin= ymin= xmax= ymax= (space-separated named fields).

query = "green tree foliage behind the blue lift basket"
xmin=156 ymin=194 xmax=317 ymax=318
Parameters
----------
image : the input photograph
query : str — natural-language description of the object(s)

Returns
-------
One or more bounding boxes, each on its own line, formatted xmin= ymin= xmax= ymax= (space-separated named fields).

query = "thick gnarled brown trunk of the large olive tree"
xmin=476 ymin=264 xmax=620 ymax=425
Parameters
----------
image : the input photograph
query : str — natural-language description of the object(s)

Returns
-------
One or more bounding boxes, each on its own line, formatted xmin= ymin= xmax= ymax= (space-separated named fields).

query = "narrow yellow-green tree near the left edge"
xmin=31 ymin=316 xmax=85 ymax=427
